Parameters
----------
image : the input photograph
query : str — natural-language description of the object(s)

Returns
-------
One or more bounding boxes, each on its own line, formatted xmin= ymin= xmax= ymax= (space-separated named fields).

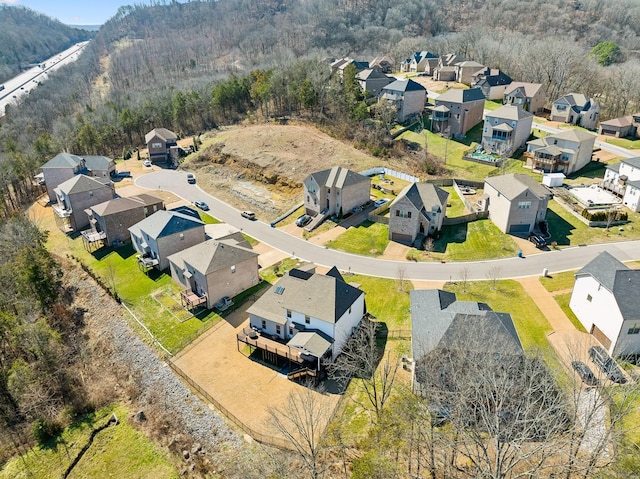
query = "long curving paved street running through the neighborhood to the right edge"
xmin=135 ymin=170 xmax=640 ymax=281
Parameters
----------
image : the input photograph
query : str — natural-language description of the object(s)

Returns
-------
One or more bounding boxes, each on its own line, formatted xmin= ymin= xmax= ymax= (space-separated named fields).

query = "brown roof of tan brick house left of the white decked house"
xmin=167 ymin=240 xmax=258 ymax=276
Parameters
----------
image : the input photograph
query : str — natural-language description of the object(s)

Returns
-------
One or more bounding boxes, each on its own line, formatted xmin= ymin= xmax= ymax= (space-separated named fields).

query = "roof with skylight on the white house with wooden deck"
xmin=247 ymin=269 xmax=364 ymax=324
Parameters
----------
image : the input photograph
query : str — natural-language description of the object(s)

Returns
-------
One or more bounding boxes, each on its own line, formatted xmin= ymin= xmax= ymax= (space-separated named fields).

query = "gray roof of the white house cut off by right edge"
xmin=576 ymin=251 xmax=640 ymax=319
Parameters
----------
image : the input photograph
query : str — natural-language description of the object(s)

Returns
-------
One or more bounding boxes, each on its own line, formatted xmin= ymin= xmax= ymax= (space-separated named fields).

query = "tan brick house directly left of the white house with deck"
xmin=167 ymin=240 xmax=260 ymax=309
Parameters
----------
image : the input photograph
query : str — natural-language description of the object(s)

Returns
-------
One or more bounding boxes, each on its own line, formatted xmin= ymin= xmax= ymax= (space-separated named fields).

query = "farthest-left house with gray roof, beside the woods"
xmin=40 ymin=153 xmax=116 ymax=201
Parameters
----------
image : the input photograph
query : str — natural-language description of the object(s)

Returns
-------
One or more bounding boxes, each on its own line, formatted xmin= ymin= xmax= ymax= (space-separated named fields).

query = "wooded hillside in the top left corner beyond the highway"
xmin=0 ymin=5 xmax=94 ymax=83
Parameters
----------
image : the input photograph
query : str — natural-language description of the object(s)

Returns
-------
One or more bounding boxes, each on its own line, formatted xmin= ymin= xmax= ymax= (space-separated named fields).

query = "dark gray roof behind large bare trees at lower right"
xmin=410 ymin=289 xmax=523 ymax=359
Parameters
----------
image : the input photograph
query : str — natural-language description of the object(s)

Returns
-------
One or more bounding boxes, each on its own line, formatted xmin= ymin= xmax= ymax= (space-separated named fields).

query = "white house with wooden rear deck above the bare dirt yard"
xmin=247 ymin=267 xmax=366 ymax=369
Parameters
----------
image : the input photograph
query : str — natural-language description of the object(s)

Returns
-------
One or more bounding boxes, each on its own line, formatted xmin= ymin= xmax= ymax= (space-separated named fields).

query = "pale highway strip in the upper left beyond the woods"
xmin=0 ymin=42 xmax=89 ymax=117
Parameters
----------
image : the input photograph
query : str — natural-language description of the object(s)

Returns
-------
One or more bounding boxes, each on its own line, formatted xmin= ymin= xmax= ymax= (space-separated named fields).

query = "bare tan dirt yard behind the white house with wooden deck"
xmin=172 ymin=296 xmax=340 ymax=446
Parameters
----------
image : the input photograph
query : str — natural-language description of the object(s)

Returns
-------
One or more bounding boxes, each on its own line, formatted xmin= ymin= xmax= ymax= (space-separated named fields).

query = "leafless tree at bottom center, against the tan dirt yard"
xmin=271 ymin=386 xmax=333 ymax=479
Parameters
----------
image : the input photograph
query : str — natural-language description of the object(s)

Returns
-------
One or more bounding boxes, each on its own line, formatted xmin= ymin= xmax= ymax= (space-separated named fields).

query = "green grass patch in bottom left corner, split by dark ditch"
xmin=0 ymin=406 xmax=179 ymax=479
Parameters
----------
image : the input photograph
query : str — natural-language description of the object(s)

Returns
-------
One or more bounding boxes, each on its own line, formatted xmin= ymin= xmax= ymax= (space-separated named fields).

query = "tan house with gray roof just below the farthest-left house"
xmin=53 ymin=174 xmax=116 ymax=232
